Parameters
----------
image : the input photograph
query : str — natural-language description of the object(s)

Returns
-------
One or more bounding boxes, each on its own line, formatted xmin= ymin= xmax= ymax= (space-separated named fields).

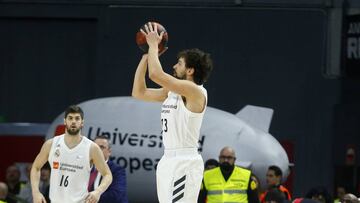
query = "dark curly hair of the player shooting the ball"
xmin=178 ymin=49 xmax=213 ymax=85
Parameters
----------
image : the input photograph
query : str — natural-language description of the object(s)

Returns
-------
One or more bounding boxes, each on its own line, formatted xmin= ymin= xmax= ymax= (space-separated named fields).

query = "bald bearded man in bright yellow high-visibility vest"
xmin=198 ymin=147 xmax=259 ymax=203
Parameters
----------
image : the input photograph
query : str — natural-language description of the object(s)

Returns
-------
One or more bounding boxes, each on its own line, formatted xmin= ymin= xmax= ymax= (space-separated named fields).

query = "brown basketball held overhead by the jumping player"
xmin=136 ymin=22 xmax=169 ymax=53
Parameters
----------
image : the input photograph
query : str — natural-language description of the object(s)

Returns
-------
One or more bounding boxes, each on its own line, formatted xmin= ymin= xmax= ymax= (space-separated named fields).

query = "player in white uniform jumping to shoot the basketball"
xmin=132 ymin=23 xmax=212 ymax=203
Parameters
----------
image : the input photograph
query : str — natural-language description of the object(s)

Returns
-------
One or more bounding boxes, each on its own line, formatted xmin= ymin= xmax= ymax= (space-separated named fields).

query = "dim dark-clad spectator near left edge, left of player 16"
xmin=5 ymin=164 xmax=25 ymax=203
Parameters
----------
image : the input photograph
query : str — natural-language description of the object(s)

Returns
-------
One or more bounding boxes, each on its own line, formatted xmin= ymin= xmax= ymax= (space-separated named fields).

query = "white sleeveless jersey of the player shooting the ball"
xmin=161 ymin=85 xmax=207 ymax=149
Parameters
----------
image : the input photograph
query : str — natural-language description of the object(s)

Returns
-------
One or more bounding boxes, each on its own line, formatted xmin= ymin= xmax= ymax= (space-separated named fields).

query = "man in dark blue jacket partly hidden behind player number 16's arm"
xmin=88 ymin=136 xmax=128 ymax=203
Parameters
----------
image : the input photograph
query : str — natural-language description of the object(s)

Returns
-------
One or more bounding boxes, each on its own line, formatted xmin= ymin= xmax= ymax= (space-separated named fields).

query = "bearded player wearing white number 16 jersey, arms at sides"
xmin=31 ymin=105 xmax=112 ymax=203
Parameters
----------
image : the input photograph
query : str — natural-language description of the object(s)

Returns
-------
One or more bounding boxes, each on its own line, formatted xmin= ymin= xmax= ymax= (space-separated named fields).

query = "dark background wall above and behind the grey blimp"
xmin=0 ymin=1 xmax=360 ymax=197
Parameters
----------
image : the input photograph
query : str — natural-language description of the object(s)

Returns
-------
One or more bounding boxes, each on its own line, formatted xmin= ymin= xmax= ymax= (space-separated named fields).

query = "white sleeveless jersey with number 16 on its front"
xmin=48 ymin=134 xmax=92 ymax=203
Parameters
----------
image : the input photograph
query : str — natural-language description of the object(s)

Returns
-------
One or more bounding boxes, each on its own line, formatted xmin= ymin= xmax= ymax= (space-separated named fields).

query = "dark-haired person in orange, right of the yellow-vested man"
xmin=260 ymin=165 xmax=291 ymax=203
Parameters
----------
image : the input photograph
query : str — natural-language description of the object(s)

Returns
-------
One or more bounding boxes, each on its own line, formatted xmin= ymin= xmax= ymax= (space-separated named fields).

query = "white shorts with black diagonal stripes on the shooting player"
xmin=156 ymin=148 xmax=204 ymax=203
